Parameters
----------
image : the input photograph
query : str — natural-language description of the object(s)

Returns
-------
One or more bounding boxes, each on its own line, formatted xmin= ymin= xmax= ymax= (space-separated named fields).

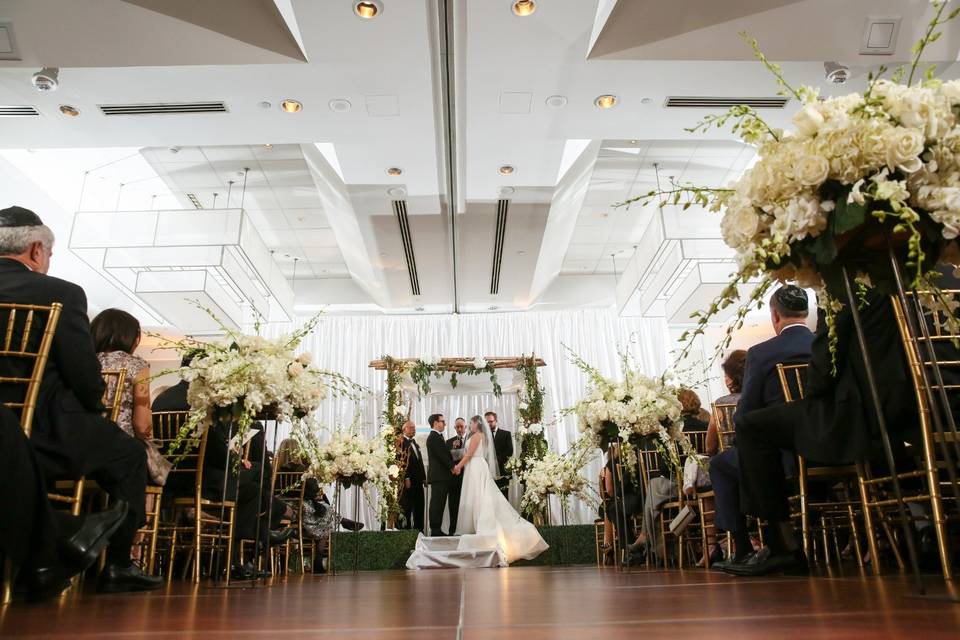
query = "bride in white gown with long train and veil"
xmin=456 ymin=416 xmax=548 ymax=564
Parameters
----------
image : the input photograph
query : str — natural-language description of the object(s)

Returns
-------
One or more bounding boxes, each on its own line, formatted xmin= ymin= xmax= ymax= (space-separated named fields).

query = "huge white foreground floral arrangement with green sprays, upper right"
xmin=620 ymin=0 xmax=960 ymax=370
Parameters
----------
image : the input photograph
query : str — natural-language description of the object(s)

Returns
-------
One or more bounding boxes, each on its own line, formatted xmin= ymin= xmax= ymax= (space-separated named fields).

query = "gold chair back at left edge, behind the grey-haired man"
xmin=0 ymin=302 xmax=63 ymax=438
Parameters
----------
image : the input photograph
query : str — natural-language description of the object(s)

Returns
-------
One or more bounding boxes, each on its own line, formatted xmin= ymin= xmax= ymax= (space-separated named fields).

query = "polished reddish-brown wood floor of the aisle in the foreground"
xmin=0 ymin=567 xmax=960 ymax=640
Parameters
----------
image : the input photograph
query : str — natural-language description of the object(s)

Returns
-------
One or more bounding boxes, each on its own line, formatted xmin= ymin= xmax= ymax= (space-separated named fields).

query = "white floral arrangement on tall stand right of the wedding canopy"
xmin=565 ymin=347 xmax=695 ymax=468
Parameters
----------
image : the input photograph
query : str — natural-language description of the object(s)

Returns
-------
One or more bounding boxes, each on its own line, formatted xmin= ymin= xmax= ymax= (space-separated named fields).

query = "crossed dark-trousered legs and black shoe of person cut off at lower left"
xmin=0 ymin=405 xmax=127 ymax=602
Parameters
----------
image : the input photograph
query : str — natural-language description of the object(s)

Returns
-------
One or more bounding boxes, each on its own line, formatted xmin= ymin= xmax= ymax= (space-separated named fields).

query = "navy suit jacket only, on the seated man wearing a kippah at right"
xmin=733 ymin=325 xmax=813 ymax=423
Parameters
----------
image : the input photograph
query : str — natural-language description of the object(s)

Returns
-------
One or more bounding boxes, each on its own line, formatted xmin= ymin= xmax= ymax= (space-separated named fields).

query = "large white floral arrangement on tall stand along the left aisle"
xmin=158 ymin=307 xmax=364 ymax=451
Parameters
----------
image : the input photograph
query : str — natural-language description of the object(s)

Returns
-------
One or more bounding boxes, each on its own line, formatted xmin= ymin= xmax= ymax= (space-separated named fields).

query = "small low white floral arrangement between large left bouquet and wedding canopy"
xmin=293 ymin=423 xmax=400 ymax=521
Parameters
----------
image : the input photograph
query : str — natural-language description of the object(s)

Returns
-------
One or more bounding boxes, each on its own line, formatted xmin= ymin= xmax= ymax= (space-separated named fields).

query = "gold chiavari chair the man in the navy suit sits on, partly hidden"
xmin=777 ymin=363 xmax=864 ymax=567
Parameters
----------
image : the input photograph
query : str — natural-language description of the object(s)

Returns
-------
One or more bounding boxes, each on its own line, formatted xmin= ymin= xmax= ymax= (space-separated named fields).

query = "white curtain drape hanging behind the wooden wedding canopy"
xmin=264 ymin=308 xmax=670 ymax=526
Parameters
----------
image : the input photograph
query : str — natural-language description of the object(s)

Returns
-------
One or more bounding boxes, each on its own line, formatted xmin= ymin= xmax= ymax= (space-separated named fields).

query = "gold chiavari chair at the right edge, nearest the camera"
xmin=860 ymin=290 xmax=960 ymax=580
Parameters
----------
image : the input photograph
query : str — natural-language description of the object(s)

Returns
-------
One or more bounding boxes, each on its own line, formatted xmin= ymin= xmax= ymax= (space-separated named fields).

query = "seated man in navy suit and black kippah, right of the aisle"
xmin=710 ymin=285 xmax=813 ymax=569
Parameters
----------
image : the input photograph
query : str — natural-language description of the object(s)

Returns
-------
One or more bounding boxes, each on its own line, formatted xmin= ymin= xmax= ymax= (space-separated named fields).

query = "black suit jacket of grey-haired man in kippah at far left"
xmin=0 ymin=258 xmax=111 ymax=477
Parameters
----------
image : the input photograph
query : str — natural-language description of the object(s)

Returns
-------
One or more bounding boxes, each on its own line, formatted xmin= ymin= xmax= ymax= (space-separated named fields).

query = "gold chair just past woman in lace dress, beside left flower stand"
xmin=168 ymin=429 xmax=236 ymax=584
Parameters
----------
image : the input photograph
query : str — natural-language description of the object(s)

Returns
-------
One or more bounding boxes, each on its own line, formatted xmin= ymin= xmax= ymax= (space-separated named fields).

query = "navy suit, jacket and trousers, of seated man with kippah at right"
xmin=710 ymin=325 xmax=813 ymax=531
